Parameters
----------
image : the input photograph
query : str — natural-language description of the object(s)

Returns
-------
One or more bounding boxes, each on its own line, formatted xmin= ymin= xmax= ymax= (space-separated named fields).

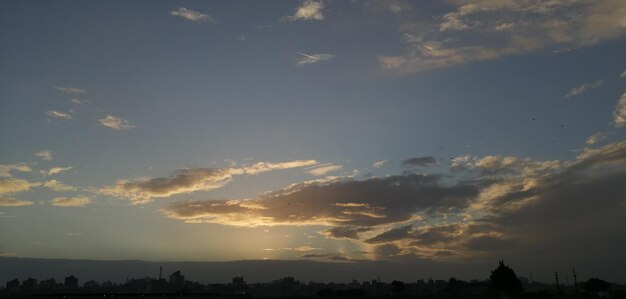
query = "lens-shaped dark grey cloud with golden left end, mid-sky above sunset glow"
xmin=165 ymin=174 xmax=478 ymax=226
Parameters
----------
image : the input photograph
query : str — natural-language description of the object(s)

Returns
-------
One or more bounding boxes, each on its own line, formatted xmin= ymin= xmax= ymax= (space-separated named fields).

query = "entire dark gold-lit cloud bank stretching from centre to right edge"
xmin=165 ymin=141 xmax=626 ymax=277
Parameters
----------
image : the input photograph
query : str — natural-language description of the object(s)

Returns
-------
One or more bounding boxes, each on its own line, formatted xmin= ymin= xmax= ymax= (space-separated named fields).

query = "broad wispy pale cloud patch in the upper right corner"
xmin=372 ymin=0 xmax=626 ymax=74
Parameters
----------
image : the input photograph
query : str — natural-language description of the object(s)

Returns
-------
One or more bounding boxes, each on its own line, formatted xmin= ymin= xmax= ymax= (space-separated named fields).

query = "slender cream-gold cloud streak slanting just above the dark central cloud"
xmin=100 ymin=160 xmax=317 ymax=204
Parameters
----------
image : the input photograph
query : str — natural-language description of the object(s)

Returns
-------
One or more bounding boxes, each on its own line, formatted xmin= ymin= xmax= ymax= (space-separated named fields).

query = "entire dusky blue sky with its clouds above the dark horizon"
xmin=0 ymin=0 xmax=626 ymax=282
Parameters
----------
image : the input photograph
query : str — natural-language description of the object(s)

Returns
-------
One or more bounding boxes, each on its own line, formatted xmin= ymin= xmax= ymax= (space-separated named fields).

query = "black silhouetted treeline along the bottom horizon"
xmin=0 ymin=262 xmax=626 ymax=298
